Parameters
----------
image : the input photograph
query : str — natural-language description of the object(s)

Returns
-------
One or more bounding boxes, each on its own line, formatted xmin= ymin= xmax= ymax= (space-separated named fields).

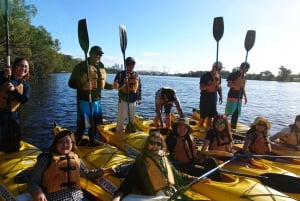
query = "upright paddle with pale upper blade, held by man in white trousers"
xmin=119 ymin=25 xmax=136 ymax=133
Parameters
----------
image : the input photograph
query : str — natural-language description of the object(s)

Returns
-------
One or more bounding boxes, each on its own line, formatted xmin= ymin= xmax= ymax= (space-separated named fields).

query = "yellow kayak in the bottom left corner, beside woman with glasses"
xmin=0 ymin=141 xmax=42 ymax=200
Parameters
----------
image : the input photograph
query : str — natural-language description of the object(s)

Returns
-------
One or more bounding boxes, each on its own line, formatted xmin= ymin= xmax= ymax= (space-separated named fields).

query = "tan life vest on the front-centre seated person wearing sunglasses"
xmin=146 ymin=157 xmax=175 ymax=192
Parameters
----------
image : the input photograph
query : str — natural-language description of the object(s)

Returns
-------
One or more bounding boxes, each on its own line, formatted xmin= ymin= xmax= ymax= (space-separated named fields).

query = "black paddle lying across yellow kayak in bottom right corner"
xmin=219 ymin=169 xmax=300 ymax=193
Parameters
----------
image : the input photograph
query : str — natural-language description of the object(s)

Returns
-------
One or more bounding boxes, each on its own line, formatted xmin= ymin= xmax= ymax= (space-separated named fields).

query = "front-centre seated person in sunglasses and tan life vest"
xmin=113 ymin=132 xmax=207 ymax=201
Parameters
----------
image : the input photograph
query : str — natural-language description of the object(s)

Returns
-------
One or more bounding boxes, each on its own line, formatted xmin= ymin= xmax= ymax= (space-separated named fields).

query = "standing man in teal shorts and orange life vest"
xmin=225 ymin=62 xmax=250 ymax=129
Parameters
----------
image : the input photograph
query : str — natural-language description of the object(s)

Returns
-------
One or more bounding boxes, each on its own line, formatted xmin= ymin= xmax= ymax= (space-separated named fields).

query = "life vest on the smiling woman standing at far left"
xmin=0 ymin=83 xmax=23 ymax=112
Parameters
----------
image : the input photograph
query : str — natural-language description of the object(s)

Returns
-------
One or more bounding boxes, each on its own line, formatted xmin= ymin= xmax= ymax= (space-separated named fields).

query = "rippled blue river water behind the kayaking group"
xmin=21 ymin=73 xmax=300 ymax=150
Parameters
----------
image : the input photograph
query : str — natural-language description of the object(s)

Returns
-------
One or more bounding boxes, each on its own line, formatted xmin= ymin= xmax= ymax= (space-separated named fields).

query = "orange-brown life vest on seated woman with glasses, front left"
xmin=43 ymin=152 xmax=81 ymax=193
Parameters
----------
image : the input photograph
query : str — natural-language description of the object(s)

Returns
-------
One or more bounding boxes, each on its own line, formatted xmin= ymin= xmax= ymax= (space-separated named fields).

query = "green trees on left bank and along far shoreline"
xmin=0 ymin=0 xmax=300 ymax=81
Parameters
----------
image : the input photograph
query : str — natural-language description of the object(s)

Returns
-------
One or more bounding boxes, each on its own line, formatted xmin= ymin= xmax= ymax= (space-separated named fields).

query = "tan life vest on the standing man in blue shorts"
xmin=81 ymin=65 xmax=106 ymax=89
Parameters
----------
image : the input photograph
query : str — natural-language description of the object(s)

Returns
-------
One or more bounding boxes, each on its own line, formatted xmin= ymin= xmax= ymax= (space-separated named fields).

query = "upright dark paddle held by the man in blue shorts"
xmin=78 ymin=19 xmax=95 ymax=146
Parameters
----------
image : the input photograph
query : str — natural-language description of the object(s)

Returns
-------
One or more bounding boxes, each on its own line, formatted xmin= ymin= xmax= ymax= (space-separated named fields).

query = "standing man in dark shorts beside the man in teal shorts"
xmin=199 ymin=62 xmax=223 ymax=128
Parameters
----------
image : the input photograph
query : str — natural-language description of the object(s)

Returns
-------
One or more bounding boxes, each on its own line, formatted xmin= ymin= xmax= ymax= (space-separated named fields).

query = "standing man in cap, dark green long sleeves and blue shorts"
xmin=69 ymin=46 xmax=112 ymax=146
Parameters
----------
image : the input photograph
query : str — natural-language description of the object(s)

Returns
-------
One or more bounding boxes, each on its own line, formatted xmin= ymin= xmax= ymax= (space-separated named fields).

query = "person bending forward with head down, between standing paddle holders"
xmin=154 ymin=87 xmax=183 ymax=129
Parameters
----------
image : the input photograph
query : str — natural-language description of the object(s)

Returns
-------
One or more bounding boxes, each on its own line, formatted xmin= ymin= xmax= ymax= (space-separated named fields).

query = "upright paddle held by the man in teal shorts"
xmin=231 ymin=30 xmax=256 ymax=129
